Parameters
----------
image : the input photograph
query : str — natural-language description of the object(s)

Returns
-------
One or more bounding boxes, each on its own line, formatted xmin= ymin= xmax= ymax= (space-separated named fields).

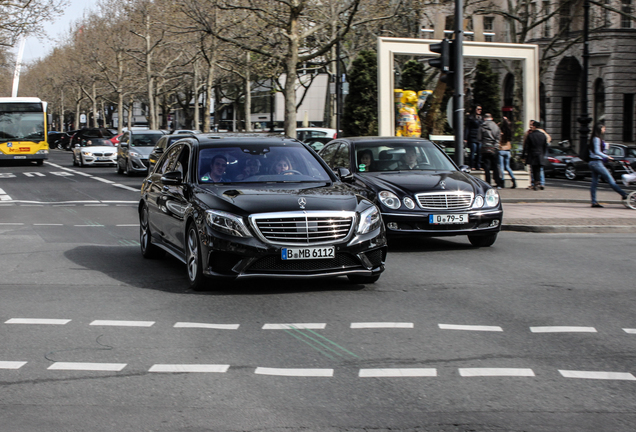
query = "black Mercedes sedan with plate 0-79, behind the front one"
xmin=319 ymin=137 xmax=503 ymax=247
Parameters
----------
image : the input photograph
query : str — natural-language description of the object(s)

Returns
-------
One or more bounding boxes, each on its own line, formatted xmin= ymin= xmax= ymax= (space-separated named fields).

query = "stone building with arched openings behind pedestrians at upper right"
xmin=422 ymin=0 xmax=636 ymax=145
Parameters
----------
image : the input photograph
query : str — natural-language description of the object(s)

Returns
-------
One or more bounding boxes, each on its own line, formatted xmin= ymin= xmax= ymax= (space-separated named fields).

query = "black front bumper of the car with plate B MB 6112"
xmin=201 ymin=229 xmax=387 ymax=279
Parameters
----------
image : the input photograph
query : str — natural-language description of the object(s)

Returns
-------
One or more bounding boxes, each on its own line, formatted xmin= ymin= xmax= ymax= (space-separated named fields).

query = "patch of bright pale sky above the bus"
xmin=14 ymin=0 xmax=97 ymax=64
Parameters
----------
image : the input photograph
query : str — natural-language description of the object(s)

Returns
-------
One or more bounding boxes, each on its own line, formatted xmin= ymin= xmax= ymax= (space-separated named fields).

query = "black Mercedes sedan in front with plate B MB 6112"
xmin=139 ymin=134 xmax=387 ymax=290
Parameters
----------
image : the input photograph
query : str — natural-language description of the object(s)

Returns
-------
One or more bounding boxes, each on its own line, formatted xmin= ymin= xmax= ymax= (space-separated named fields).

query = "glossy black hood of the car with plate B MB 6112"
xmin=197 ymin=183 xmax=363 ymax=215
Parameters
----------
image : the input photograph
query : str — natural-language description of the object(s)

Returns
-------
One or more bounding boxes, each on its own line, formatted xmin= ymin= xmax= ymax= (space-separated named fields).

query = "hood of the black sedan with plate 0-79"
xmin=356 ymin=171 xmax=487 ymax=195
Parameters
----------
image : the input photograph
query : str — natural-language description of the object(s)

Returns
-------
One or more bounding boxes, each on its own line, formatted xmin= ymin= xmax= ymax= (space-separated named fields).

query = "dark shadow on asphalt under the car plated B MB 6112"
xmin=64 ymin=246 xmax=365 ymax=295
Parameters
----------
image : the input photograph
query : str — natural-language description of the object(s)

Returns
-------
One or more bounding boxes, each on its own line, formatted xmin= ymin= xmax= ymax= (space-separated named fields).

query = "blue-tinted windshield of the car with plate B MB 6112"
xmin=197 ymin=144 xmax=331 ymax=183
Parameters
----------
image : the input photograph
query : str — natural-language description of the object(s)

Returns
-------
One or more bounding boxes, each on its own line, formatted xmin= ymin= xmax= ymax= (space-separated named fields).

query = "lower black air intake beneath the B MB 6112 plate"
xmin=246 ymin=253 xmax=360 ymax=273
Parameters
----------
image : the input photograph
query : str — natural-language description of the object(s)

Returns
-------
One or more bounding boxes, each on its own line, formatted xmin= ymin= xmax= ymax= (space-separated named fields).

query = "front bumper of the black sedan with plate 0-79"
xmin=382 ymin=208 xmax=503 ymax=237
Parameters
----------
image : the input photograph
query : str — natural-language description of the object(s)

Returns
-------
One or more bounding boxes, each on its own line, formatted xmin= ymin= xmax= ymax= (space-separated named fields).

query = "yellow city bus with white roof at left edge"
xmin=0 ymin=97 xmax=49 ymax=165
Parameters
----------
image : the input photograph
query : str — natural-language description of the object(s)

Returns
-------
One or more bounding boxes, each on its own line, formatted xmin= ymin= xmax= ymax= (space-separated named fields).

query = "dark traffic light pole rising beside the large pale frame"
xmin=453 ymin=0 xmax=464 ymax=166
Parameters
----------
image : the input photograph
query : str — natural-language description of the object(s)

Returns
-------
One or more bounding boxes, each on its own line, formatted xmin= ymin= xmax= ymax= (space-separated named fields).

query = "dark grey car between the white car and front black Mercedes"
xmin=117 ymin=129 xmax=164 ymax=176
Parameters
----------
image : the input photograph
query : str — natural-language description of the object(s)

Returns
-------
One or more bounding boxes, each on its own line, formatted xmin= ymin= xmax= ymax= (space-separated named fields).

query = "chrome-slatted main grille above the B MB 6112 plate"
xmin=251 ymin=212 xmax=354 ymax=245
